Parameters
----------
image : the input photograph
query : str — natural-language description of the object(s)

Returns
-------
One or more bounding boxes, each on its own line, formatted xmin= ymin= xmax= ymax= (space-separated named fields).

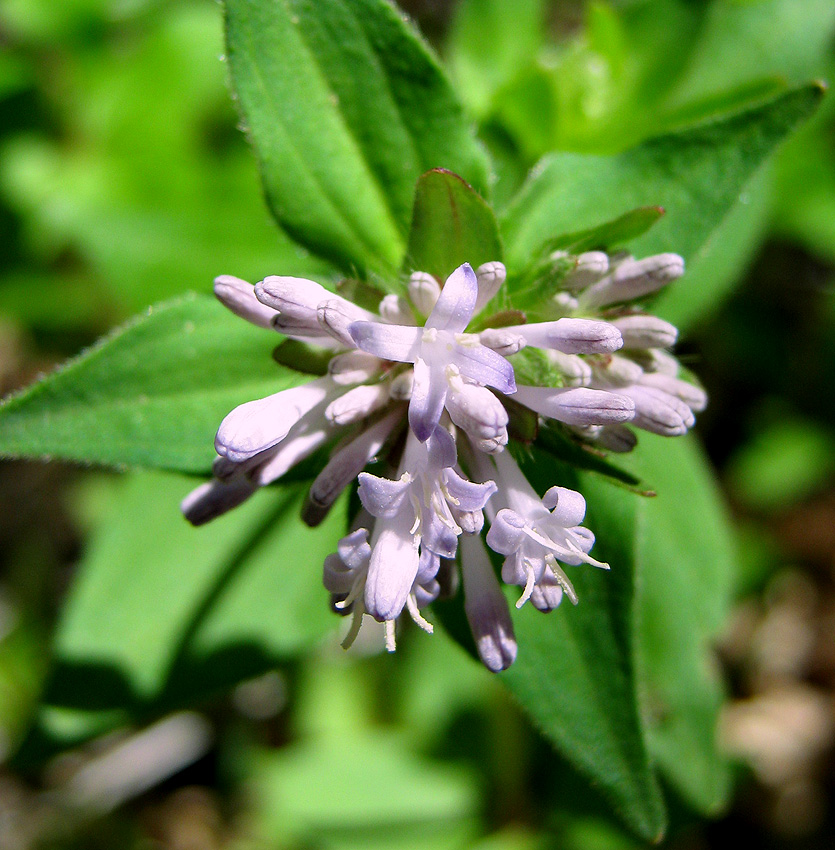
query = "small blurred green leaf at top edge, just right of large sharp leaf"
xmin=446 ymin=0 xmax=545 ymax=115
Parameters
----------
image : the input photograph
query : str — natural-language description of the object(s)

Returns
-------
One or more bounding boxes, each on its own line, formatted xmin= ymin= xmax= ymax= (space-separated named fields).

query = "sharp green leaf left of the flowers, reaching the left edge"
xmin=0 ymin=296 xmax=298 ymax=472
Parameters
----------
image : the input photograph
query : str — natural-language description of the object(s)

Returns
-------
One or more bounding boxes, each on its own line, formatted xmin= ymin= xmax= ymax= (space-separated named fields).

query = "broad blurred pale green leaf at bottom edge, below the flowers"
xmin=243 ymin=730 xmax=477 ymax=850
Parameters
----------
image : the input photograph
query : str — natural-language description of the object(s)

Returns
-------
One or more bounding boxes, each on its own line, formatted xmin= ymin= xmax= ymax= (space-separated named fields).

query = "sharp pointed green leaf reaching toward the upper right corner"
xmin=502 ymin=85 xmax=823 ymax=274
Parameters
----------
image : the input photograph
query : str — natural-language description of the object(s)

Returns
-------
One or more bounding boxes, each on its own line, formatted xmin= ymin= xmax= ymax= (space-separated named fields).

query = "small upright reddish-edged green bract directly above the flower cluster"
xmin=406 ymin=168 xmax=502 ymax=280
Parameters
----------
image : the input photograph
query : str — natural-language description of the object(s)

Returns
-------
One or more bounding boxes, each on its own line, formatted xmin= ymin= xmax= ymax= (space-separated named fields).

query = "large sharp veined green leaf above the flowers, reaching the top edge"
xmin=226 ymin=0 xmax=487 ymax=275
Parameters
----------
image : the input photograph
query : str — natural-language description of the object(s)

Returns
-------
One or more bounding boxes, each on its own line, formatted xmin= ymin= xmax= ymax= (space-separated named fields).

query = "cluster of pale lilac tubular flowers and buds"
xmin=182 ymin=252 xmax=706 ymax=671
